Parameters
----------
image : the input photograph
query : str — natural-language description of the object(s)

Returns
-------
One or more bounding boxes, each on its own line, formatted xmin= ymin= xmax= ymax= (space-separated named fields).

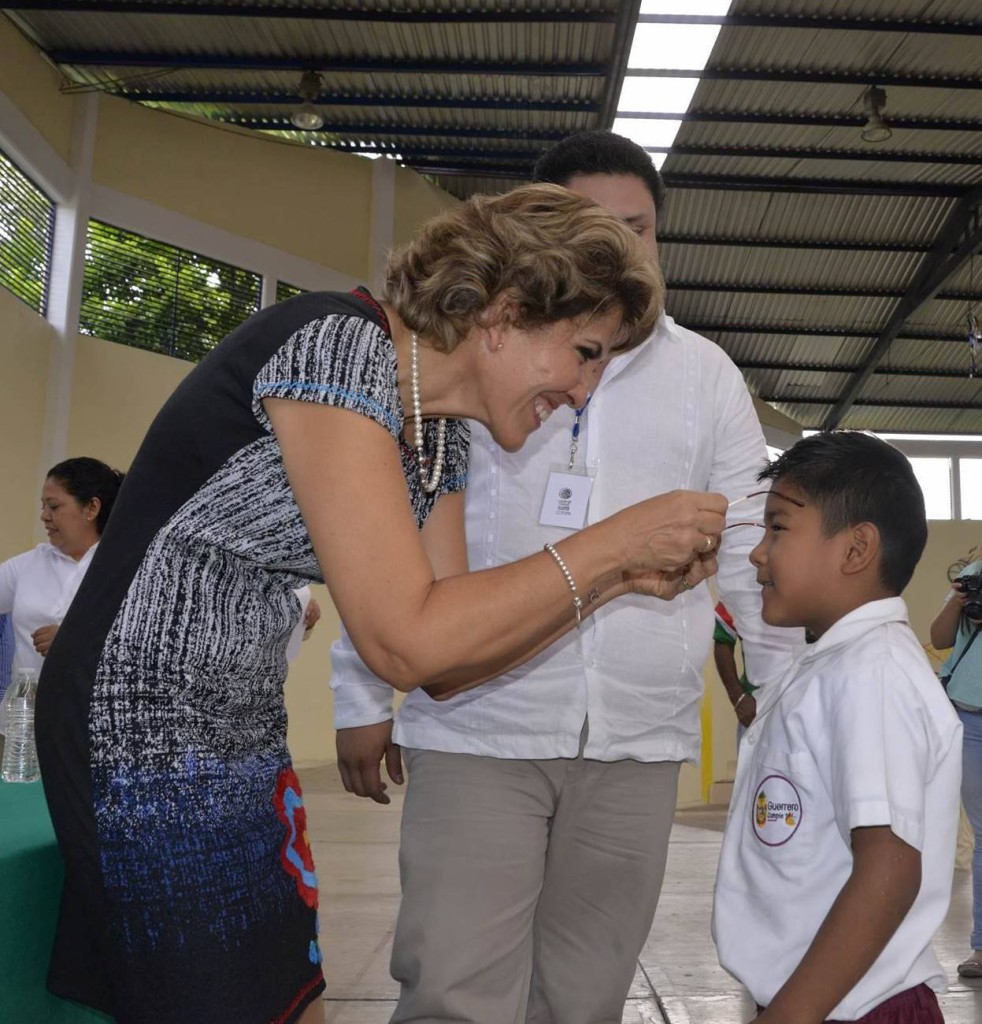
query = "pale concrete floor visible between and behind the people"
xmin=300 ymin=765 xmax=982 ymax=1024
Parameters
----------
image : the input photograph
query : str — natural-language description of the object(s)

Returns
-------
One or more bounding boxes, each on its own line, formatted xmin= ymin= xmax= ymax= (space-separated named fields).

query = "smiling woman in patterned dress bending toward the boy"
xmin=37 ymin=185 xmax=726 ymax=1024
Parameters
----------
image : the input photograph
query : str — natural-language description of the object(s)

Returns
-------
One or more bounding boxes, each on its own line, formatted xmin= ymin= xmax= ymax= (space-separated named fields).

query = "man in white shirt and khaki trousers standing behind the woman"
xmin=332 ymin=132 xmax=800 ymax=1024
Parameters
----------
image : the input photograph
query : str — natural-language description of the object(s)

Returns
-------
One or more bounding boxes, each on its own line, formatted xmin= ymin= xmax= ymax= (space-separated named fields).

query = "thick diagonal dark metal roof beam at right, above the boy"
xmin=822 ymin=185 xmax=982 ymax=430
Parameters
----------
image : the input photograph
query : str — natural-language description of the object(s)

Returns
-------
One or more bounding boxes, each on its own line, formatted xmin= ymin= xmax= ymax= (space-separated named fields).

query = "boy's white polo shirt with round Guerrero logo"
xmin=713 ymin=597 xmax=962 ymax=1020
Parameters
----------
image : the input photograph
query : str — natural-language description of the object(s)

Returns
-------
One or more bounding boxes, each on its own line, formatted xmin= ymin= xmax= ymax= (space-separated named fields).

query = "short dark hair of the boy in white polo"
xmin=758 ymin=430 xmax=928 ymax=594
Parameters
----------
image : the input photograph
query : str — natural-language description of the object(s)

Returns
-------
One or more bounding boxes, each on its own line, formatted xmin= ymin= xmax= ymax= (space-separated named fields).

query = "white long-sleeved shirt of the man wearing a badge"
xmin=331 ymin=315 xmax=804 ymax=762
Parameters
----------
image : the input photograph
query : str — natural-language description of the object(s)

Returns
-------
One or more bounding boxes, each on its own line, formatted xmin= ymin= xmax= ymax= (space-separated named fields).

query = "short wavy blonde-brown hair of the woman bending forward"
xmin=383 ymin=184 xmax=665 ymax=352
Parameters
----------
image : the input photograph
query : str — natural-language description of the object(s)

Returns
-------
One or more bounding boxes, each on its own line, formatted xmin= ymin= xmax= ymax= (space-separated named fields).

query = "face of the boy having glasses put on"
xmin=750 ymin=479 xmax=843 ymax=636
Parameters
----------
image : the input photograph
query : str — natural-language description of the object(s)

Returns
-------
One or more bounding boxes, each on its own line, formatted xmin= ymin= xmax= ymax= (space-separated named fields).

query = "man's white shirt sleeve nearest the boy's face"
xmin=710 ymin=357 xmax=805 ymax=686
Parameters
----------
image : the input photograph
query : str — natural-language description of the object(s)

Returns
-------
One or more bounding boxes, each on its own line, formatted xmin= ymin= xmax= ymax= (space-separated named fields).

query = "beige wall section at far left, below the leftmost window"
xmin=0 ymin=288 xmax=57 ymax=560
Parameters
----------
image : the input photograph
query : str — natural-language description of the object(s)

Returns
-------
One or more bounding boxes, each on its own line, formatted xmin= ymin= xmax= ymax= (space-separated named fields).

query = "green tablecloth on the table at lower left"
xmin=0 ymin=781 xmax=112 ymax=1024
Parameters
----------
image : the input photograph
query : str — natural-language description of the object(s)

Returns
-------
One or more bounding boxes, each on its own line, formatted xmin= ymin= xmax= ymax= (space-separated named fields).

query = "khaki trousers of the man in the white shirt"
xmin=391 ymin=750 xmax=679 ymax=1024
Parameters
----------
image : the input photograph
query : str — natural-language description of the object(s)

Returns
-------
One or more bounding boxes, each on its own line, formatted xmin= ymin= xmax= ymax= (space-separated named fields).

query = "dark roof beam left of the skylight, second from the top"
xmin=51 ymin=49 xmax=607 ymax=78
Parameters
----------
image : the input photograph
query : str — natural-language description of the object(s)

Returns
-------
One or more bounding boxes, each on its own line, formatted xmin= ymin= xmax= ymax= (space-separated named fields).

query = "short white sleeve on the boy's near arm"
xmin=824 ymin=651 xmax=937 ymax=850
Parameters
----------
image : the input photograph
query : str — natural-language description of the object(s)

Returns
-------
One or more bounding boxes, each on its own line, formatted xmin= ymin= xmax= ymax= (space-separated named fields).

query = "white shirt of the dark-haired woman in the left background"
xmin=0 ymin=544 xmax=98 ymax=672
